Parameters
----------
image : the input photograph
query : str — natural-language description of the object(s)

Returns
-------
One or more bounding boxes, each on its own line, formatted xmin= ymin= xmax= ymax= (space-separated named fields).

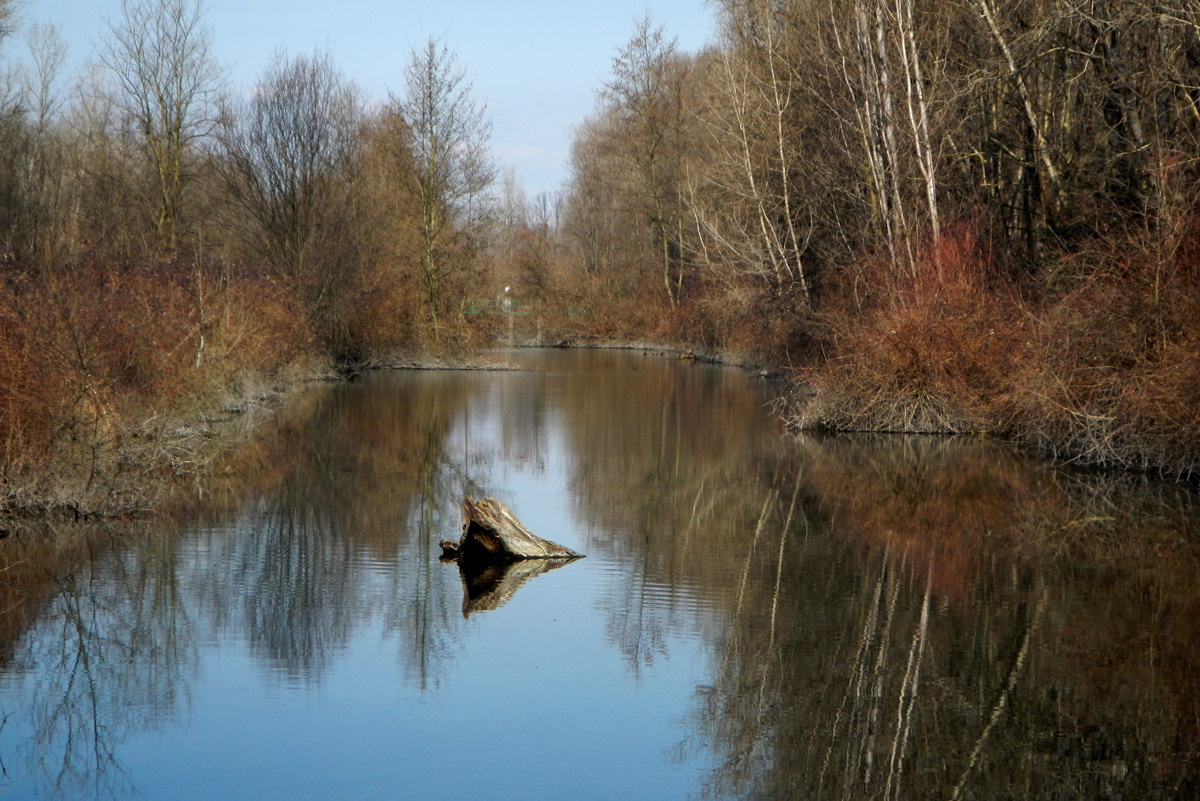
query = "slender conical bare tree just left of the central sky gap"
xmin=391 ymin=38 xmax=496 ymax=327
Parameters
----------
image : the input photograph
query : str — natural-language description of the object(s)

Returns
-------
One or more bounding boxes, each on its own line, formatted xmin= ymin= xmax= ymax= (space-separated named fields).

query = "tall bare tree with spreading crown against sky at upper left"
xmin=100 ymin=0 xmax=221 ymax=249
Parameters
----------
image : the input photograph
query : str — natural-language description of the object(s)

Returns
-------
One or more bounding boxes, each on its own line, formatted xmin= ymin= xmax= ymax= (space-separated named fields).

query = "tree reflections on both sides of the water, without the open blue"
xmin=0 ymin=354 xmax=1200 ymax=799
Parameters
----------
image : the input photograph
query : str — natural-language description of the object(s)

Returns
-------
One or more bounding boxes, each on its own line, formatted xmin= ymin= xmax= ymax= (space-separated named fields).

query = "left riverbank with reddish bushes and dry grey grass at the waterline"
xmin=0 ymin=260 xmax=482 ymax=528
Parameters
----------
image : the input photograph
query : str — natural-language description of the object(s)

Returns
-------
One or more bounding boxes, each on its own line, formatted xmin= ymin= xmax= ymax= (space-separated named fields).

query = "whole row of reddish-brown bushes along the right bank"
xmin=792 ymin=216 xmax=1200 ymax=475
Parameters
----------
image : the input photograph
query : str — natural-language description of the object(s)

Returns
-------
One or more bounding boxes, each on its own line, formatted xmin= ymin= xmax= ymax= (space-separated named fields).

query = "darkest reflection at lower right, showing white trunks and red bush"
xmin=657 ymin=439 xmax=1200 ymax=799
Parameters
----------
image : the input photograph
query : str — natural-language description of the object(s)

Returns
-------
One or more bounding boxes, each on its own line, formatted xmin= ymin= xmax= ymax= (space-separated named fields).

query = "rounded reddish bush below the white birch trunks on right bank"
xmin=794 ymin=225 xmax=1028 ymax=433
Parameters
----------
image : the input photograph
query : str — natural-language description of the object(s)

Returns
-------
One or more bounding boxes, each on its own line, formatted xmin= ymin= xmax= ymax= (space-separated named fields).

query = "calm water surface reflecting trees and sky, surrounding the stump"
xmin=0 ymin=351 xmax=1200 ymax=800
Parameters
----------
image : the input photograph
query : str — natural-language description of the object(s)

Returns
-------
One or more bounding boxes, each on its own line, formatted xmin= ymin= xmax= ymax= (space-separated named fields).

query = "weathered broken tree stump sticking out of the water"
xmin=442 ymin=495 xmax=583 ymax=561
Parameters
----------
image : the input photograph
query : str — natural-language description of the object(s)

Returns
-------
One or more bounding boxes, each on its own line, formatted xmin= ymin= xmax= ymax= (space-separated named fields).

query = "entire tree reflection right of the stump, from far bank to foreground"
xmin=542 ymin=363 xmax=1200 ymax=799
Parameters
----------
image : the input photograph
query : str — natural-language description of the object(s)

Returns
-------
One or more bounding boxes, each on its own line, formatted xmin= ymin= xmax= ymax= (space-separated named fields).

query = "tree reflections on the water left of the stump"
xmin=0 ymin=374 xmax=484 ymax=797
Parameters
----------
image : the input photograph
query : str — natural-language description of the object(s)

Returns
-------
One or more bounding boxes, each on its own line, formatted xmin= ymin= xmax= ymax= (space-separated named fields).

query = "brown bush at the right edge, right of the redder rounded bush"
xmin=1010 ymin=221 xmax=1200 ymax=475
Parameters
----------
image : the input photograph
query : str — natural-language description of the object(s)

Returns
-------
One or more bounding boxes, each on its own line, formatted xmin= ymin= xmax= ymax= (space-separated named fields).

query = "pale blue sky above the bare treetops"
xmin=18 ymin=0 xmax=714 ymax=198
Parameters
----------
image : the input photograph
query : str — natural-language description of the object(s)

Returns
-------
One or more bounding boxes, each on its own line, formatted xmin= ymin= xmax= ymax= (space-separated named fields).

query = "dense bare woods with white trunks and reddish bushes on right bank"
xmin=560 ymin=0 xmax=1200 ymax=474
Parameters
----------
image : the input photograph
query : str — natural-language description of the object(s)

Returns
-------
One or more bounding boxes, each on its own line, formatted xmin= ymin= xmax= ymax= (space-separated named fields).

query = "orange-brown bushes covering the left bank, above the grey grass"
xmin=0 ymin=257 xmax=308 ymax=512
